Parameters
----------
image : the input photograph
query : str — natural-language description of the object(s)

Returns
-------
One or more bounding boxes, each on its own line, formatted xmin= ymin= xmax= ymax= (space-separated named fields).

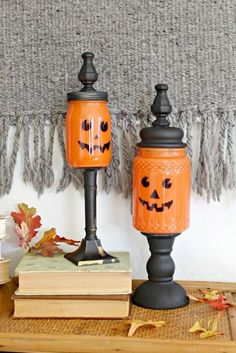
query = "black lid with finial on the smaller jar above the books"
xmin=67 ymin=52 xmax=108 ymax=101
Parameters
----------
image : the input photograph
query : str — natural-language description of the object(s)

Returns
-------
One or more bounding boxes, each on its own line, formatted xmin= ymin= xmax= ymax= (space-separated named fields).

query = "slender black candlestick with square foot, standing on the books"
xmin=65 ymin=168 xmax=119 ymax=266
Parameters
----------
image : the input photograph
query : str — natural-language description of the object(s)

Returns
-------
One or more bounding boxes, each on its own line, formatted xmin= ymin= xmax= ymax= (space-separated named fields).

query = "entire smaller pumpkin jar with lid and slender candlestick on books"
xmin=65 ymin=52 xmax=119 ymax=266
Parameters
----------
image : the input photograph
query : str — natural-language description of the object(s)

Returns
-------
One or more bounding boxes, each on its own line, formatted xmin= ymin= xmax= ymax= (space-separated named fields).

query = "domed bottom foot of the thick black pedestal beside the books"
xmin=132 ymin=281 xmax=189 ymax=310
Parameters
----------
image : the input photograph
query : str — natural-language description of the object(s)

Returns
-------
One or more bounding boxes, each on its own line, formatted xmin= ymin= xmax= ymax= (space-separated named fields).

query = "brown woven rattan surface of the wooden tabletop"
xmin=0 ymin=291 xmax=231 ymax=341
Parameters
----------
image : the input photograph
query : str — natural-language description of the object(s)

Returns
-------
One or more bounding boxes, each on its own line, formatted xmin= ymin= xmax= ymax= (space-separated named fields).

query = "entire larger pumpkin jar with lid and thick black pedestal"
xmin=132 ymin=84 xmax=190 ymax=309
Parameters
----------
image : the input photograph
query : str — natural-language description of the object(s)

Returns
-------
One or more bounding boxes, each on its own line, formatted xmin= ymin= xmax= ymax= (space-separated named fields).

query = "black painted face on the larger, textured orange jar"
xmin=139 ymin=176 xmax=173 ymax=212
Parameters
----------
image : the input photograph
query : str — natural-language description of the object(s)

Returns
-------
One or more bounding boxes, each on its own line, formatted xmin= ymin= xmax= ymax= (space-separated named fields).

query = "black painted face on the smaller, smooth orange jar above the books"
xmin=78 ymin=120 xmax=111 ymax=154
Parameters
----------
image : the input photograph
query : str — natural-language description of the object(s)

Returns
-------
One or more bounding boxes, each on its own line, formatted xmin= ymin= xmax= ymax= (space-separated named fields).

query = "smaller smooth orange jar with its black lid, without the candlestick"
xmin=66 ymin=53 xmax=112 ymax=168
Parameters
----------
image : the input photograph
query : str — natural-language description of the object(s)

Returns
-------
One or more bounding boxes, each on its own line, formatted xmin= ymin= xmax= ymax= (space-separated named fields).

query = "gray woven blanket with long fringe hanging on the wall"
xmin=0 ymin=0 xmax=236 ymax=200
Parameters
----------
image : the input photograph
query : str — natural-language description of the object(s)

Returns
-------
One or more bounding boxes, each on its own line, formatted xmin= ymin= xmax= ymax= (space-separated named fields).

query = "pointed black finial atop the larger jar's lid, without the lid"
xmin=151 ymin=83 xmax=172 ymax=127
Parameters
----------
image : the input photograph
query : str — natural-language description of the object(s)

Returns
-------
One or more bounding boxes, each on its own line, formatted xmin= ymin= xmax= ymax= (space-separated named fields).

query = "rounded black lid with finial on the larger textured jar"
xmin=138 ymin=84 xmax=186 ymax=148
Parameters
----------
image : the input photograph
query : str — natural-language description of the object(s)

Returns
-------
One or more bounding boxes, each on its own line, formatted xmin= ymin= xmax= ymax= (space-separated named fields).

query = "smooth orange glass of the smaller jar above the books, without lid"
xmin=66 ymin=100 xmax=112 ymax=168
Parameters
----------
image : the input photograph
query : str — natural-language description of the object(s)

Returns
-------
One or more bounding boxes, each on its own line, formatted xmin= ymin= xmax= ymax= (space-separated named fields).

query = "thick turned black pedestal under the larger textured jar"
xmin=132 ymin=234 xmax=189 ymax=309
